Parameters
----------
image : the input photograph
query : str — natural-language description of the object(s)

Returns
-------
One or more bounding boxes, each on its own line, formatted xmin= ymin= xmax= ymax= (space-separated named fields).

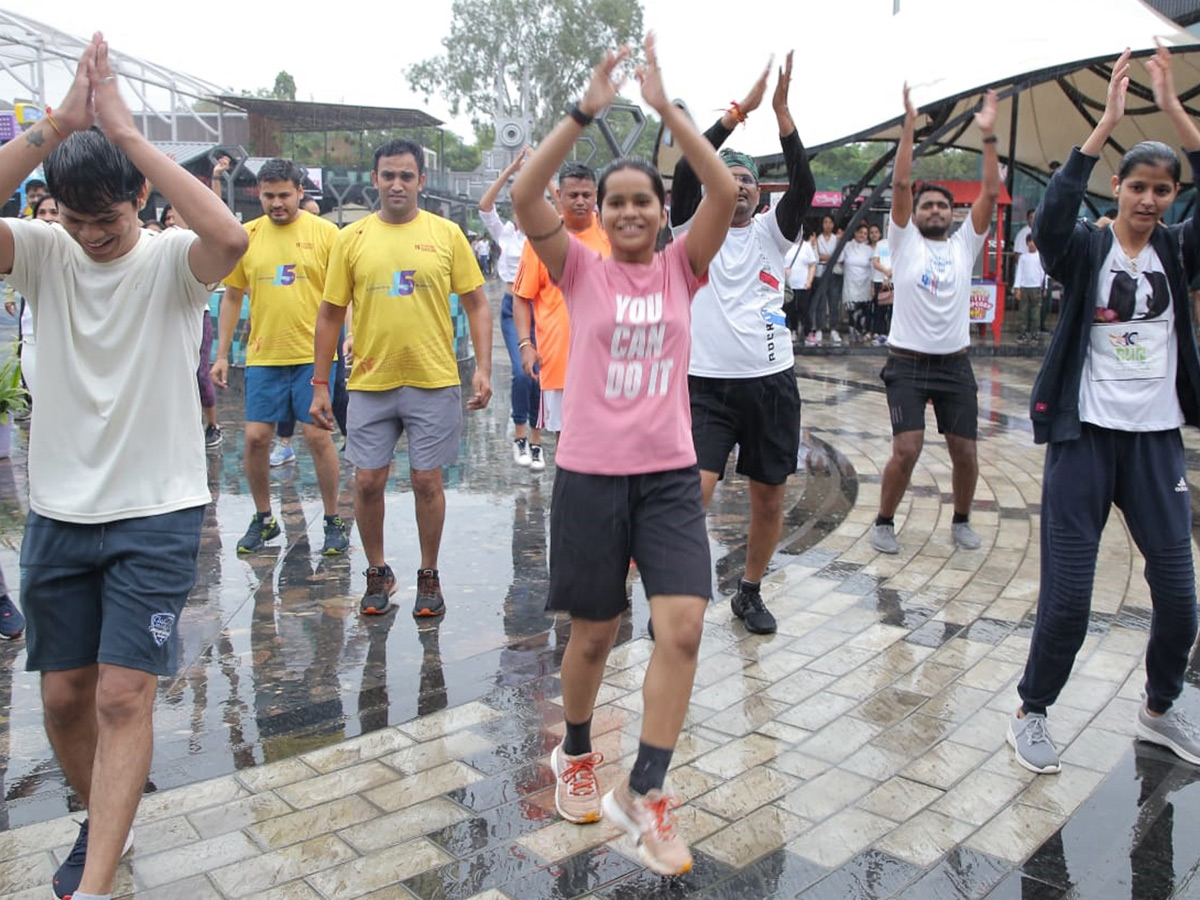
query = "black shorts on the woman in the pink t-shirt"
xmin=546 ymin=466 xmax=713 ymax=622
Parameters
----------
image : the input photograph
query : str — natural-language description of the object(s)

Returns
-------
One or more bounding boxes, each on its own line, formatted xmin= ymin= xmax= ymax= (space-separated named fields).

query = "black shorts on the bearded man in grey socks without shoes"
xmin=880 ymin=349 xmax=979 ymax=440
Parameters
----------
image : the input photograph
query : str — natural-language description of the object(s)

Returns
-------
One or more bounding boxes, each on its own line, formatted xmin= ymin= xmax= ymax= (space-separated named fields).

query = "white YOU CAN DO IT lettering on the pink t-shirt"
xmin=604 ymin=292 xmax=674 ymax=398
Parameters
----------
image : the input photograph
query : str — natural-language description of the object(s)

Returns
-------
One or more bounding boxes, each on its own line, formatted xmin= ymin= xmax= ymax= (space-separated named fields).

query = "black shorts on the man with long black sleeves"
xmin=688 ymin=370 xmax=800 ymax=485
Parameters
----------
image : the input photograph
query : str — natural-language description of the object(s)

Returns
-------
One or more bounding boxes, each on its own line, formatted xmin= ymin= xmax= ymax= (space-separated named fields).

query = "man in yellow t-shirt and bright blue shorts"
xmin=212 ymin=160 xmax=349 ymax=554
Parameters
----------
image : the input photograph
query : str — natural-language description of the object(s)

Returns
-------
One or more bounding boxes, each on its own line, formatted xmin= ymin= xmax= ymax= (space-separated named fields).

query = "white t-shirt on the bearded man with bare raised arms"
xmin=888 ymin=216 xmax=988 ymax=354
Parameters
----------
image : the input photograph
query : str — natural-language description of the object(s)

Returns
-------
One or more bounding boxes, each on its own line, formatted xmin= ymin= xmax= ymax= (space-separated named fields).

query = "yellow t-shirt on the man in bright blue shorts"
xmin=224 ymin=211 xmax=337 ymax=366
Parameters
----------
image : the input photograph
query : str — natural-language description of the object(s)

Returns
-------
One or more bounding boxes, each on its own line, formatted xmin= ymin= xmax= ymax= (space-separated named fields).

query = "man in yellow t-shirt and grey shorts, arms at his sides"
xmin=312 ymin=140 xmax=492 ymax=616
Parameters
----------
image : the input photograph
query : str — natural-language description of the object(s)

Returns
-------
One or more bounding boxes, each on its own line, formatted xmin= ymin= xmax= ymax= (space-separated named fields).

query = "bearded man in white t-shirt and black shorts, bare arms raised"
xmin=871 ymin=85 xmax=1001 ymax=553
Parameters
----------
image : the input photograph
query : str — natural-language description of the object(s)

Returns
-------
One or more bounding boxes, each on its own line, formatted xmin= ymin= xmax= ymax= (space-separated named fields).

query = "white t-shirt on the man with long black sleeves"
xmin=673 ymin=210 xmax=796 ymax=378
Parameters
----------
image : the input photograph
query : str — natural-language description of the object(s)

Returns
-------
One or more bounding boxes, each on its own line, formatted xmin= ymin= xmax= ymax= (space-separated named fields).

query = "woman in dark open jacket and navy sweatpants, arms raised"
xmin=1008 ymin=47 xmax=1200 ymax=773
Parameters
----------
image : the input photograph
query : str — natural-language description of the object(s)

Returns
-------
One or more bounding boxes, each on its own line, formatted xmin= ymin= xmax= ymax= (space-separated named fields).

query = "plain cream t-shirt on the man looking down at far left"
xmin=7 ymin=220 xmax=212 ymax=524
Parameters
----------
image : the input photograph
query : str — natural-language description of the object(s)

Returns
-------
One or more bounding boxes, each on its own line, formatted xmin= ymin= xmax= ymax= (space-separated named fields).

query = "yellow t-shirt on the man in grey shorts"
xmin=325 ymin=210 xmax=484 ymax=391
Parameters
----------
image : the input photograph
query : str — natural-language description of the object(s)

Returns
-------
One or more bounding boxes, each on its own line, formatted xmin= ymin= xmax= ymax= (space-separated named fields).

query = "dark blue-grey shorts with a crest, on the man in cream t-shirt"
xmin=20 ymin=506 xmax=204 ymax=676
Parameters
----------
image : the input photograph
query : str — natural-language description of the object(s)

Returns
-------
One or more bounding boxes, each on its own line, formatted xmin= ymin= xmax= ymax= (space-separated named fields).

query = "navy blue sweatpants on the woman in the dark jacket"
xmin=1018 ymin=422 xmax=1196 ymax=713
